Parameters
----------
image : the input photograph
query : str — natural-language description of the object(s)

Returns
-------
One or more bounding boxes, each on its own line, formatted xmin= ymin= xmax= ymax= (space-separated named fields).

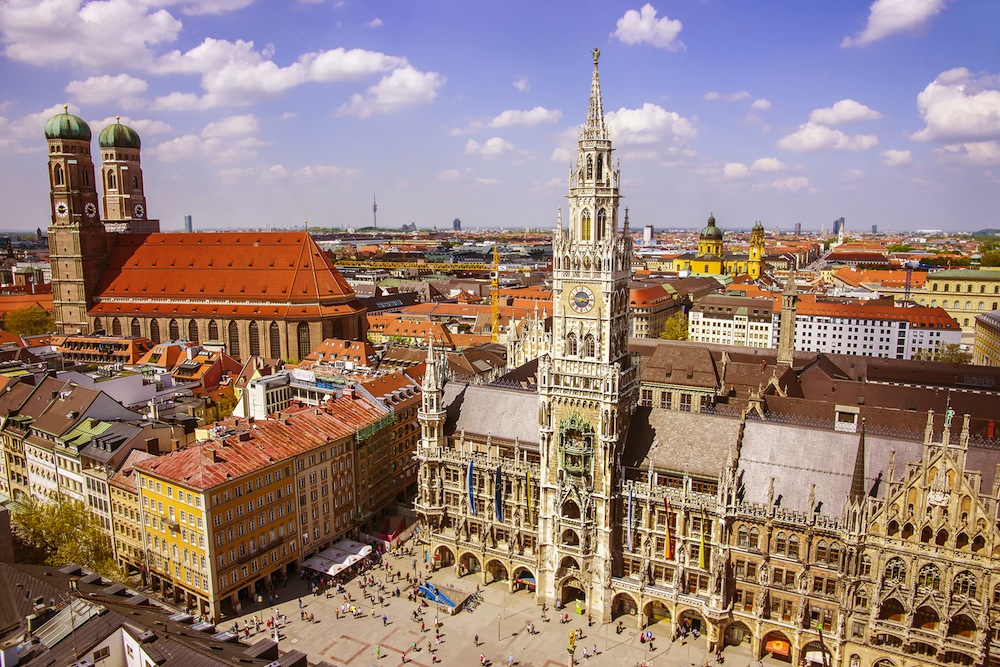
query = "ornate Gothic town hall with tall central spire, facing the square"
xmin=416 ymin=50 xmax=1000 ymax=667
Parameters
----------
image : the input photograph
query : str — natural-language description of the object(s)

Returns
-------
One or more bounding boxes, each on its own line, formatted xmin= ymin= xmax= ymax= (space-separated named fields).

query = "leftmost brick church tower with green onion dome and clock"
xmin=45 ymin=107 xmax=107 ymax=334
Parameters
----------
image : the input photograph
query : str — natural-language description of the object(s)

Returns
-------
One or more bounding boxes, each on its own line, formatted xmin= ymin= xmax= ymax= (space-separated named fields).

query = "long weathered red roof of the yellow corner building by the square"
xmin=136 ymin=396 xmax=386 ymax=491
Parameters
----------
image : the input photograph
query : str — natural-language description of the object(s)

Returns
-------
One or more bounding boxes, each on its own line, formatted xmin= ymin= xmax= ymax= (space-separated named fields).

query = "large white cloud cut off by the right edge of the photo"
xmin=910 ymin=67 xmax=1000 ymax=142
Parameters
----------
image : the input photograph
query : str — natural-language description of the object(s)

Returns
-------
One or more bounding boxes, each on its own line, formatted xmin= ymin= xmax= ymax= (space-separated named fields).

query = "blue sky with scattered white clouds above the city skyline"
xmin=0 ymin=0 xmax=1000 ymax=235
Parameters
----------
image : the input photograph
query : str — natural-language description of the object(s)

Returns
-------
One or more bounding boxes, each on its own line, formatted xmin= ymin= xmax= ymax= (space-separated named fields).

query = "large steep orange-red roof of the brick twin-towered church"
xmin=92 ymin=232 xmax=354 ymax=308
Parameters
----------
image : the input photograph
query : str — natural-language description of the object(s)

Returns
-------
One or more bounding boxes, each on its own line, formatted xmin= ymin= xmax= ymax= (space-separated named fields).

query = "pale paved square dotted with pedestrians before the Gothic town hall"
xmin=221 ymin=556 xmax=785 ymax=667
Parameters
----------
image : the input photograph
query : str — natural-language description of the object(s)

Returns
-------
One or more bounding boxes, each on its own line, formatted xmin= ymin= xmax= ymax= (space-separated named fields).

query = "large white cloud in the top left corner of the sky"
xmin=0 ymin=0 xmax=181 ymax=68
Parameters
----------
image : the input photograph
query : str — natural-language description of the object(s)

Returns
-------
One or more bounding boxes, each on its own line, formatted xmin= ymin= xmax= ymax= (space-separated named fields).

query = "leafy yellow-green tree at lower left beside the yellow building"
xmin=12 ymin=496 xmax=126 ymax=580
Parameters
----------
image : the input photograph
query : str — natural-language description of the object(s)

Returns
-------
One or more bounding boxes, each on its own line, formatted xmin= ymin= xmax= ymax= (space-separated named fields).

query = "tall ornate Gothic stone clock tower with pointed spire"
xmin=538 ymin=49 xmax=638 ymax=620
